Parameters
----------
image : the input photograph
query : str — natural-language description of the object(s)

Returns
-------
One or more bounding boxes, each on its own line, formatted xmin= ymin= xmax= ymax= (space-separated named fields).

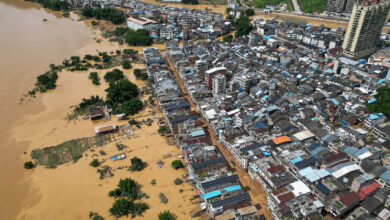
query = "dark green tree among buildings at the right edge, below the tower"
xmin=368 ymin=86 xmax=390 ymax=118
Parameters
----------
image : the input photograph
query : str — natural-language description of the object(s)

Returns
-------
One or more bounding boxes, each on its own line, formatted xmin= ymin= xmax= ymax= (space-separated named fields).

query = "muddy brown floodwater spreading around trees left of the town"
xmin=0 ymin=0 xmax=196 ymax=220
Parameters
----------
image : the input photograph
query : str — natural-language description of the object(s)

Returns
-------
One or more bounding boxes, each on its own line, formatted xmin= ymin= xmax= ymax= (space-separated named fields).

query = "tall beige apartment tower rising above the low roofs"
xmin=343 ymin=0 xmax=390 ymax=59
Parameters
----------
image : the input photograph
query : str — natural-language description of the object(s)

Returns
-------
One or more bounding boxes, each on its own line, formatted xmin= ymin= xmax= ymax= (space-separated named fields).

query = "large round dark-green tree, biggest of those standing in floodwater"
xmin=105 ymin=79 xmax=139 ymax=103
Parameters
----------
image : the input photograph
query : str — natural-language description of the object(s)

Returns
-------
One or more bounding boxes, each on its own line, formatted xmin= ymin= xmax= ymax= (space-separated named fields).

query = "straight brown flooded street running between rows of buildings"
xmin=167 ymin=56 xmax=272 ymax=219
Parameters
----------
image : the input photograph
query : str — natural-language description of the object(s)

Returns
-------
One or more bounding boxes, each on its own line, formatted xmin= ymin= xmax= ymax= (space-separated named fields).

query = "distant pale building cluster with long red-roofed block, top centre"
xmin=123 ymin=0 xmax=231 ymax=40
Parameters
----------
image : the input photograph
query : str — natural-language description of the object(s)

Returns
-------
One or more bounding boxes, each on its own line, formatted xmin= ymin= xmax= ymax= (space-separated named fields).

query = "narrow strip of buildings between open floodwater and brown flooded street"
xmin=144 ymin=48 xmax=257 ymax=219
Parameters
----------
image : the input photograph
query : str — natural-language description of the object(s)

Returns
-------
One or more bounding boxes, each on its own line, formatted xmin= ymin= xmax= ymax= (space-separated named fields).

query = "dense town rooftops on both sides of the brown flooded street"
xmin=146 ymin=6 xmax=390 ymax=219
